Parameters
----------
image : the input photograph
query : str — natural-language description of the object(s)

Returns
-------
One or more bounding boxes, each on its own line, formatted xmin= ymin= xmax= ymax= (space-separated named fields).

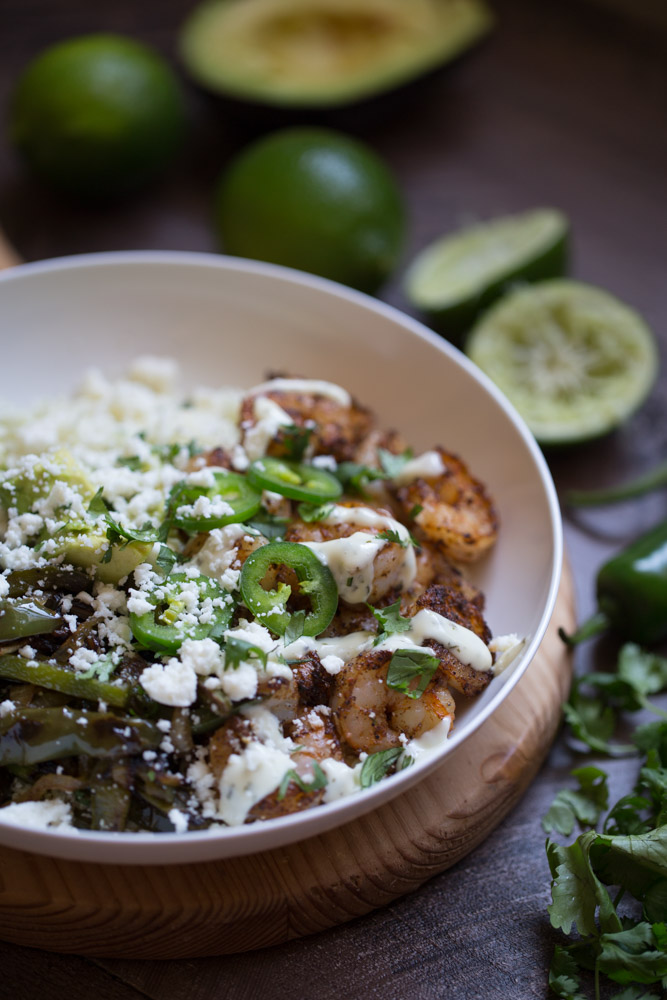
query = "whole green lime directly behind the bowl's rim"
xmin=215 ymin=128 xmax=405 ymax=292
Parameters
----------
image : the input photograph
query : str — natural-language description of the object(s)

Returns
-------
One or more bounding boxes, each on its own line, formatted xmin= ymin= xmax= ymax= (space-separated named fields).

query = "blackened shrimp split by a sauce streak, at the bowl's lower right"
xmin=405 ymin=584 xmax=493 ymax=695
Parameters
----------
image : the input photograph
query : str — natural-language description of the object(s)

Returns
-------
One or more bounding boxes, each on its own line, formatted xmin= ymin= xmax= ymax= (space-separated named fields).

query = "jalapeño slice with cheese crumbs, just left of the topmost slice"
xmin=169 ymin=471 xmax=261 ymax=534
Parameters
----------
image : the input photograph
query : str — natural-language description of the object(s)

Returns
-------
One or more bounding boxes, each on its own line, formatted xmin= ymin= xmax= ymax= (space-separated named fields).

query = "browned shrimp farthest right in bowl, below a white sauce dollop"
xmin=395 ymin=448 xmax=498 ymax=562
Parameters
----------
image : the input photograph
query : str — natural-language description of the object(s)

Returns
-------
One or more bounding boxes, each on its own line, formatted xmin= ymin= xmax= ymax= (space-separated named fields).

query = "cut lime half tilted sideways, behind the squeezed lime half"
xmin=405 ymin=208 xmax=569 ymax=339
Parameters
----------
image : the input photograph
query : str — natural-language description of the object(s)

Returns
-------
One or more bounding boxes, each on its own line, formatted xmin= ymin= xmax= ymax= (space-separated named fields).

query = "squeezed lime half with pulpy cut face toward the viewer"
xmin=466 ymin=280 xmax=659 ymax=445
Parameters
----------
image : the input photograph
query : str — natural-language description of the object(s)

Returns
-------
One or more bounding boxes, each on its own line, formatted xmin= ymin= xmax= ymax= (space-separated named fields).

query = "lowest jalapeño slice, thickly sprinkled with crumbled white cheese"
xmin=130 ymin=573 xmax=233 ymax=653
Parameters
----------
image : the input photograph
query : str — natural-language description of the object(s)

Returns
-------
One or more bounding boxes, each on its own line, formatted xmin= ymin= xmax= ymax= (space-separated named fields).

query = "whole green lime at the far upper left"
xmin=10 ymin=35 xmax=184 ymax=197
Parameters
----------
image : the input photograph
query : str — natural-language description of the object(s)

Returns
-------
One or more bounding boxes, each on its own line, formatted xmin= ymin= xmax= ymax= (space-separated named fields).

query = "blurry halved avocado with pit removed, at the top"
xmin=180 ymin=0 xmax=493 ymax=108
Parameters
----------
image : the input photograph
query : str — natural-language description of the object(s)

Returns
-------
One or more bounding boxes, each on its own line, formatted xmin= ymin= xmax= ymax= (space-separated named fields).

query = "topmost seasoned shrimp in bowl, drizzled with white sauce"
xmin=241 ymin=379 xmax=373 ymax=462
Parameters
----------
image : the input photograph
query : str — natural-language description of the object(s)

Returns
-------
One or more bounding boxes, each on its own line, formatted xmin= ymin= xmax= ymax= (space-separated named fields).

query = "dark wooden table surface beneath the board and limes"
xmin=0 ymin=0 xmax=667 ymax=1000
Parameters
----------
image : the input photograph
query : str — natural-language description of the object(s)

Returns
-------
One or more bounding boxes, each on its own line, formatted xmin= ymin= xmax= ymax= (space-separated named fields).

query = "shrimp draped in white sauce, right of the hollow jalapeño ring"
xmin=285 ymin=502 xmax=416 ymax=604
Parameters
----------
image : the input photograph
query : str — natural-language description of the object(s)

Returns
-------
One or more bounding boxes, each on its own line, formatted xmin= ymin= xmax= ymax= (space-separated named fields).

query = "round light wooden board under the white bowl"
xmin=0 ymin=566 xmax=575 ymax=959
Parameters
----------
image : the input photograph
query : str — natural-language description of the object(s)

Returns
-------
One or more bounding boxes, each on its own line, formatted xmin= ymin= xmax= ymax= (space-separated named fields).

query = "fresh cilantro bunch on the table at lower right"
xmin=542 ymin=643 xmax=667 ymax=1000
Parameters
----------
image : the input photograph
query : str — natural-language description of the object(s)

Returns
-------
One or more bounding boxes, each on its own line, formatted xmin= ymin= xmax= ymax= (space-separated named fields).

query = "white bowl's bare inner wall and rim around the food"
xmin=0 ymin=251 xmax=562 ymax=864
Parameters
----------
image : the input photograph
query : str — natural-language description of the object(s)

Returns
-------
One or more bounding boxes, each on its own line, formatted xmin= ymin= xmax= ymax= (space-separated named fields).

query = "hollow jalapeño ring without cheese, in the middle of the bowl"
xmin=239 ymin=542 xmax=338 ymax=635
